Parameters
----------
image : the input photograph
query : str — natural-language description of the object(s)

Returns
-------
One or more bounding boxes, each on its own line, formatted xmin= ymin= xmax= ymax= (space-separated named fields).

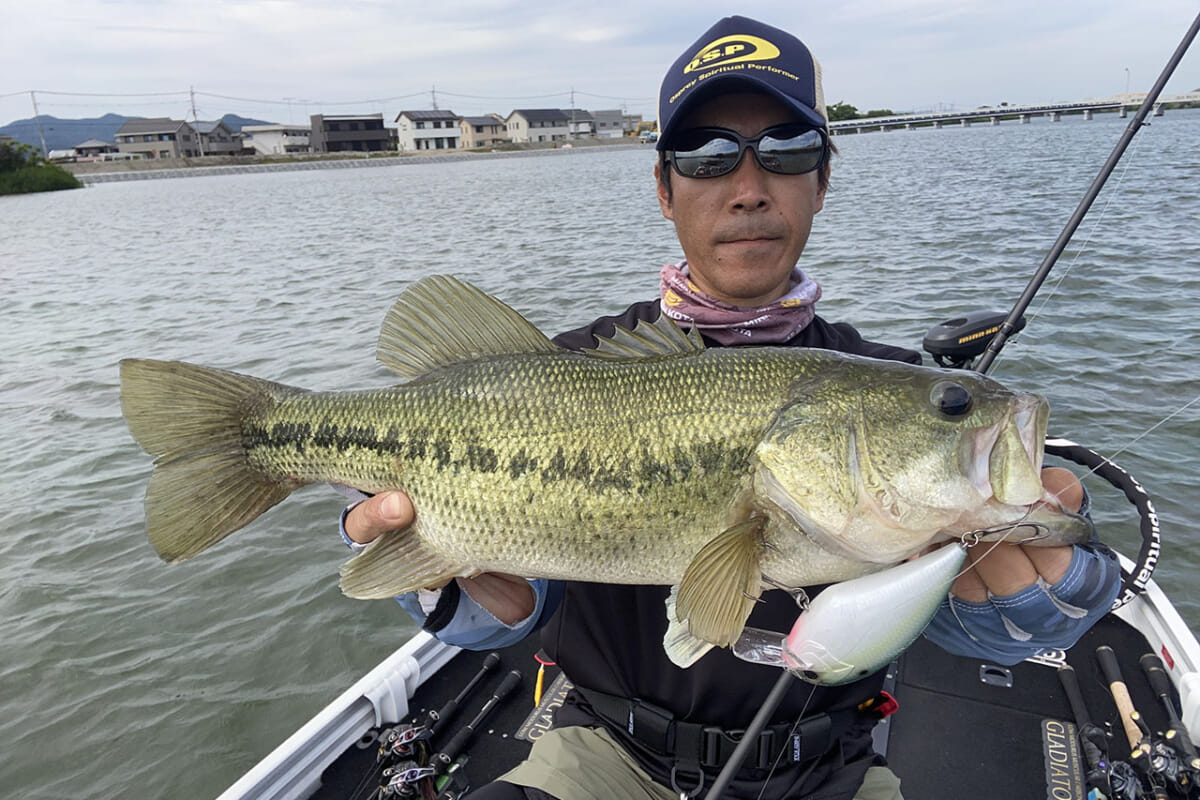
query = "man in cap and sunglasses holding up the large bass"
xmin=342 ymin=17 xmax=1118 ymax=800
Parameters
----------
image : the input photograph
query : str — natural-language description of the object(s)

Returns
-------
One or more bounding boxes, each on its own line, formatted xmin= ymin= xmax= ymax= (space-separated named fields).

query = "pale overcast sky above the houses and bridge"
xmin=0 ymin=0 xmax=1200 ymax=125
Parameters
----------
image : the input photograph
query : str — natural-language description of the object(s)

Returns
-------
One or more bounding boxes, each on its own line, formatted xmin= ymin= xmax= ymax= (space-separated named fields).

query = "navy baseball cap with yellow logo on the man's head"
xmin=658 ymin=17 xmax=829 ymax=150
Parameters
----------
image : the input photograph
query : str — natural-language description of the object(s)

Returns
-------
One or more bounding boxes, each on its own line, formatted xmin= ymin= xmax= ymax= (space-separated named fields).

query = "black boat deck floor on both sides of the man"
xmin=314 ymin=614 xmax=1177 ymax=800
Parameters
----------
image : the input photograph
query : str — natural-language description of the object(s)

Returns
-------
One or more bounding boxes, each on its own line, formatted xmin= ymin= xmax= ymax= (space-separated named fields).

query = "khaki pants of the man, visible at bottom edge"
xmin=498 ymin=726 xmax=904 ymax=800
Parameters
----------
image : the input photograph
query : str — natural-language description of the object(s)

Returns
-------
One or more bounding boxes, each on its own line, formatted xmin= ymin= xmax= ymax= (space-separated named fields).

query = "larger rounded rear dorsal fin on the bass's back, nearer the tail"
xmin=376 ymin=275 xmax=562 ymax=378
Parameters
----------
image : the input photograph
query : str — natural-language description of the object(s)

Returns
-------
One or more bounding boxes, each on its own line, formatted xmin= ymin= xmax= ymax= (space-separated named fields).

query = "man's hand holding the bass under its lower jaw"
xmin=950 ymin=467 xmax=1084 ymax=603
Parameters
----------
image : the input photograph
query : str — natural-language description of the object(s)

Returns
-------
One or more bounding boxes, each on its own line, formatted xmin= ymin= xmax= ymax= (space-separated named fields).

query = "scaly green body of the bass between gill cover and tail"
xmin=235 ymin=350 xmax=818 ymax=583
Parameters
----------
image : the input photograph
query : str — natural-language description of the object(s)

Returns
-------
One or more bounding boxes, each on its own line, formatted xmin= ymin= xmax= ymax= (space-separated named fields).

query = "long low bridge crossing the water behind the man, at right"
xmin=829 ymin=91 xmax=1200 ymax=134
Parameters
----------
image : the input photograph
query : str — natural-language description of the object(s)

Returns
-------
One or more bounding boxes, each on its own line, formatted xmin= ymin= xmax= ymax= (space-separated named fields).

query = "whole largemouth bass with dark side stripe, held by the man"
xmin=121 ymin=276 xmax=1090 ymax=662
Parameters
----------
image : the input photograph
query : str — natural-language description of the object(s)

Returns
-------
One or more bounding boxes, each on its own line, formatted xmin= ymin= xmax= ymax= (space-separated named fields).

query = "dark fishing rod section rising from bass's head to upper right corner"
xmin=974 ymin=8 xmax=1200 ymax=374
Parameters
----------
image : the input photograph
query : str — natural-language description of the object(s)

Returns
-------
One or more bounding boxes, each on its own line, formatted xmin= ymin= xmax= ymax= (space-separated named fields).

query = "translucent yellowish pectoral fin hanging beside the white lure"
xmin=676 ymin=516 xmax=767 ymax=646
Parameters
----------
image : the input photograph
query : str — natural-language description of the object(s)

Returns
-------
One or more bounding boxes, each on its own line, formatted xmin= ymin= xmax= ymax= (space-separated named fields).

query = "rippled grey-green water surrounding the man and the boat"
xmin=0 ymin=112 xmax=1200 ymax=800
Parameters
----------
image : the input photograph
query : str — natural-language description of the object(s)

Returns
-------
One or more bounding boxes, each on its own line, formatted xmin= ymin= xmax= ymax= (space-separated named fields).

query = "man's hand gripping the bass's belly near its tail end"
xmin=343 ymin=492 xmax=536 ymax=625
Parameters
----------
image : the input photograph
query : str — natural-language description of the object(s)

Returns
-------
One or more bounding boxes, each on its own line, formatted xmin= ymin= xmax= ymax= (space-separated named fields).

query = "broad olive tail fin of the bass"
xmin=121 ymin=359 xmax=300 ymax=561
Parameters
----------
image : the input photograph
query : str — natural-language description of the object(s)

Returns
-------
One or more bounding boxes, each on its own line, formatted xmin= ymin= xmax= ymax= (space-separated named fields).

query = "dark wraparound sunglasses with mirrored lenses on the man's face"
xmin=666 ymin=125 xmax=829 ymax=178
